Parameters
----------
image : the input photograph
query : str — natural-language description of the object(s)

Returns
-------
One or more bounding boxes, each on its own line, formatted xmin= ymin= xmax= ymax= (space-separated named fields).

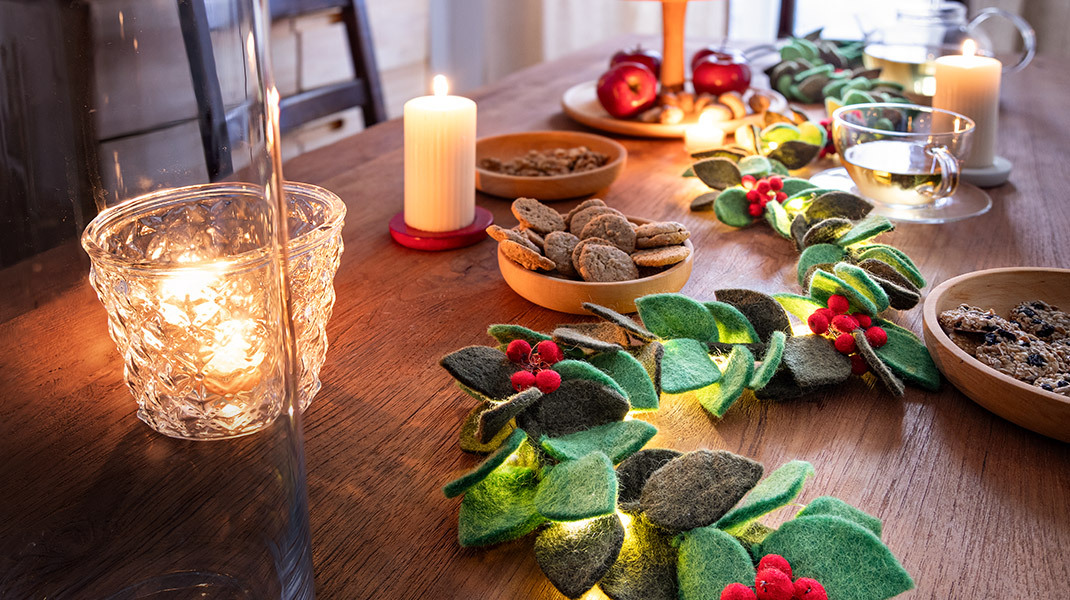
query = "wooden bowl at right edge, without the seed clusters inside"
xmin=922 ymin=267 xmax=1070 ymax=442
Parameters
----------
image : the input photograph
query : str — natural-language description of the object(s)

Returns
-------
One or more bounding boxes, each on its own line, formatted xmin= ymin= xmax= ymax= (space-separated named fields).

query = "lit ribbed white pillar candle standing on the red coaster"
xmin=404 ymin=75 xmax=475 ymax=232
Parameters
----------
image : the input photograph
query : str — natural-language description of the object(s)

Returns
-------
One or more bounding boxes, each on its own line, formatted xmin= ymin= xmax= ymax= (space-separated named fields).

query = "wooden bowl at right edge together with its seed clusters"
xmin=922 ymin=267 xmax=1070 ymax=442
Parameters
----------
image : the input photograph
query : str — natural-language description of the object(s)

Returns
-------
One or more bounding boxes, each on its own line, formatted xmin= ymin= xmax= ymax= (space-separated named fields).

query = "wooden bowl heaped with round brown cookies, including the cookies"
xmin=487 ymin=198 xmax=694 ymax=314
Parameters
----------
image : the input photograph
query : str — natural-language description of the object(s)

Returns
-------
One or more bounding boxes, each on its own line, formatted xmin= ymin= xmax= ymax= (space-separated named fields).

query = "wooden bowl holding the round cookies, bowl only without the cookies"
xmin=498 ymin=217 xmax=694 ymax=314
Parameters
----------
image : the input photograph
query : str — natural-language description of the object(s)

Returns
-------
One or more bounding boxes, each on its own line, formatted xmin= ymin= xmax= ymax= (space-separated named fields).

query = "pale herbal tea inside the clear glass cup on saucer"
xmin=843 ymin=140 xmax=944 ymax=206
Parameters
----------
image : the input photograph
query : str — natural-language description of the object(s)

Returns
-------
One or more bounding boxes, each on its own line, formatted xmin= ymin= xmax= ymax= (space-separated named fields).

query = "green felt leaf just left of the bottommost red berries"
xmin=676 ymin=526 xmax=754 ymax=600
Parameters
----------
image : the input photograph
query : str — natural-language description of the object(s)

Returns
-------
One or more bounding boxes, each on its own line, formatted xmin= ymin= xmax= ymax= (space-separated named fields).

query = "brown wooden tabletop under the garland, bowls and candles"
xmin=0 ymin=43 xmax=1070 ymax=599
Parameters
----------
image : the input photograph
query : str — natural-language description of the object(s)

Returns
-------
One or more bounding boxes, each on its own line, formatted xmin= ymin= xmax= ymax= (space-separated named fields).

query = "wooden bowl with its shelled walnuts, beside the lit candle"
xmin=475 ymin=132 xmax=628 ymax=201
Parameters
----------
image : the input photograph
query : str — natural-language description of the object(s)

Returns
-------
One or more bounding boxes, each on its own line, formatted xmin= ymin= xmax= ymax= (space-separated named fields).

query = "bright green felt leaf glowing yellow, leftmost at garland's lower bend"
xmin=457 ymin=465 xmax=546 ymax=547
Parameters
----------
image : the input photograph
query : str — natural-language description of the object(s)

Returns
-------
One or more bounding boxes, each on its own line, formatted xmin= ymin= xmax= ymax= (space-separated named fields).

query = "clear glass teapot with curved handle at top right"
xmin=862 ymin=0 xmax=1037 ymax=96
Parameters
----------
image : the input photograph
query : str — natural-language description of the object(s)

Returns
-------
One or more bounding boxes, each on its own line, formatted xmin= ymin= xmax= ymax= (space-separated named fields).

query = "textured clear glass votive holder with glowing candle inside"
xmin=82 ymin=183 xmax=346 ymax=440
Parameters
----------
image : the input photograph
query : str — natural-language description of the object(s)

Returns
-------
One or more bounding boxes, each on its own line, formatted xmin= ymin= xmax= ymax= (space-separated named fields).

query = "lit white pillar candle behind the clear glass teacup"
xmin=933 ymin=40 xmax=1003 ymax=169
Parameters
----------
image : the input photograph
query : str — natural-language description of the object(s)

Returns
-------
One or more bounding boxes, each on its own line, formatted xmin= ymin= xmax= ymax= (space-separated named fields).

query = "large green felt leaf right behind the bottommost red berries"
xmin=762 ymin=514 xmax=914 ymax=600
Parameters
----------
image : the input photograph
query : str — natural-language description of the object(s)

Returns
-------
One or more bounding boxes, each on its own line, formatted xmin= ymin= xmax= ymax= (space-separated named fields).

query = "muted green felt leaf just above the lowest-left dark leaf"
xmin=535 ymin=452 xmax=616 ymax=521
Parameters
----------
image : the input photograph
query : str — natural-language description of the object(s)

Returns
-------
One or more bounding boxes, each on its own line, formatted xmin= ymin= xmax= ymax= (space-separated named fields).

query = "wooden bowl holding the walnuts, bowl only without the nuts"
xmin=475 ymin=132 xmax=628 ymax=201
